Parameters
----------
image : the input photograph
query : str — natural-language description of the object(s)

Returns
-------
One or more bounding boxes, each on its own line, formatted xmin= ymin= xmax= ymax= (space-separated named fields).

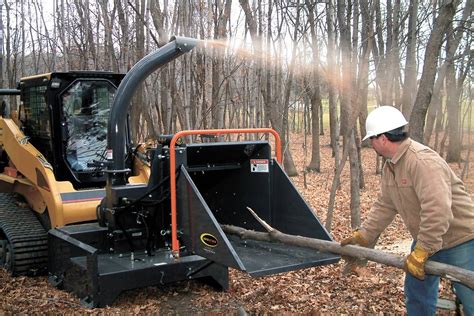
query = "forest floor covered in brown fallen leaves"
xmin=0 ymin=135 xmax=474 ymax=315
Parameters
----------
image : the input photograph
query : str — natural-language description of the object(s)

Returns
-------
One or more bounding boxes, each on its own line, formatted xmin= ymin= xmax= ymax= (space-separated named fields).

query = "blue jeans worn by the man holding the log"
xmin=405 ymin=240 xmax=474 ymax=316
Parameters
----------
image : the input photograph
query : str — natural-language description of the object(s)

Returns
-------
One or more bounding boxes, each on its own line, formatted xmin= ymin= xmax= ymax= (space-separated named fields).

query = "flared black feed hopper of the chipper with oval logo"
xmin=171 ymin=130 xmax=339 ymax=276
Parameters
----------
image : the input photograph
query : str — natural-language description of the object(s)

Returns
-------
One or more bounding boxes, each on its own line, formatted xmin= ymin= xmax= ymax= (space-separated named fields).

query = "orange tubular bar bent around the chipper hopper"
xmin=170 ymin=128 xmax=282 ymax=258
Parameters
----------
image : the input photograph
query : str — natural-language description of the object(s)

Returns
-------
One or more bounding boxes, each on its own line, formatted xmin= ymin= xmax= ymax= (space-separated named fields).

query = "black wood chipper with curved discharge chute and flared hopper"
xmin=0 ymin=38 xmax=339 ymax=307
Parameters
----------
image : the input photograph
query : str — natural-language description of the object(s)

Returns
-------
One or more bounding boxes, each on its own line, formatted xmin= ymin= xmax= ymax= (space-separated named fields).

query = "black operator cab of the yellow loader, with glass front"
xmin=19 ymin=71 xmax=123 ymax=189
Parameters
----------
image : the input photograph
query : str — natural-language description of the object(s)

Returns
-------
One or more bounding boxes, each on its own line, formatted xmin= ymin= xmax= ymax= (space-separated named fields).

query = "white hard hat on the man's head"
xmin=362 ymin=105 xmax=408 ymax=141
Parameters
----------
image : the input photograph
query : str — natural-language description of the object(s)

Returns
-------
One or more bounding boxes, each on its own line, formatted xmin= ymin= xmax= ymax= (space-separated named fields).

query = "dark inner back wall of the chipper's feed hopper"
xmin=187 ymin=141 xmax=272 ymax=231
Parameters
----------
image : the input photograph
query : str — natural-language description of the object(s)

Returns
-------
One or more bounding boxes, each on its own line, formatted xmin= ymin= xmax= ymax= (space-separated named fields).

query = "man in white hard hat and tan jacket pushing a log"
xmin=341 ymin=106 xmax=474 ymax=315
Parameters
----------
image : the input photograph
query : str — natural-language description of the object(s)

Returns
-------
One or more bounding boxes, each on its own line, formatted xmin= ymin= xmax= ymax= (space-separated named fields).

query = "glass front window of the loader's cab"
xmin=61 ymin=80 xmax=116 ymax=171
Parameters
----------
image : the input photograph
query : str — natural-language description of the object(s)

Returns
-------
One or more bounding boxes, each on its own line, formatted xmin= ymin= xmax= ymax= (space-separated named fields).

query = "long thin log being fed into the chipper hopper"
xmin=221 ymin=225 xmax=474 ymax=289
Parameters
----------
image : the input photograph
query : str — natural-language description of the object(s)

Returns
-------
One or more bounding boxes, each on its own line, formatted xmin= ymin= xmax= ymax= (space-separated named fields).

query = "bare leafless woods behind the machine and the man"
xmin=0 ymin=0 xmax=474 ymax=229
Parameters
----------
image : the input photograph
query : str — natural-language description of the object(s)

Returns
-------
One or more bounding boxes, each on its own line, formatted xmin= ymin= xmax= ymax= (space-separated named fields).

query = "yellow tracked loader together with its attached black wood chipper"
xmin=0 ymin=37 xmax=339 ymax=307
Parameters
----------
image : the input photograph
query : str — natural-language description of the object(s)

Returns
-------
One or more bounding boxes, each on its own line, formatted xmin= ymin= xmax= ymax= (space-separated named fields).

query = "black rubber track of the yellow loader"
xmin=0 ymin=193 xmax=48 ymax=276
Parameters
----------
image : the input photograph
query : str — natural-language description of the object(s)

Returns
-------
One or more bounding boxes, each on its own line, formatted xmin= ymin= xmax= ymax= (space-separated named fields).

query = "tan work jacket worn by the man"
xmin=361 ymin=138 xmax=474 ymax=254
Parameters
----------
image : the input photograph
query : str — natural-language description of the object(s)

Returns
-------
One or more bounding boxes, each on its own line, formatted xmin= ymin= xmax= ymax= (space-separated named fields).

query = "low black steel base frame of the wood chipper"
xmin=49 ymin=225 xmax=229 ymax=307
